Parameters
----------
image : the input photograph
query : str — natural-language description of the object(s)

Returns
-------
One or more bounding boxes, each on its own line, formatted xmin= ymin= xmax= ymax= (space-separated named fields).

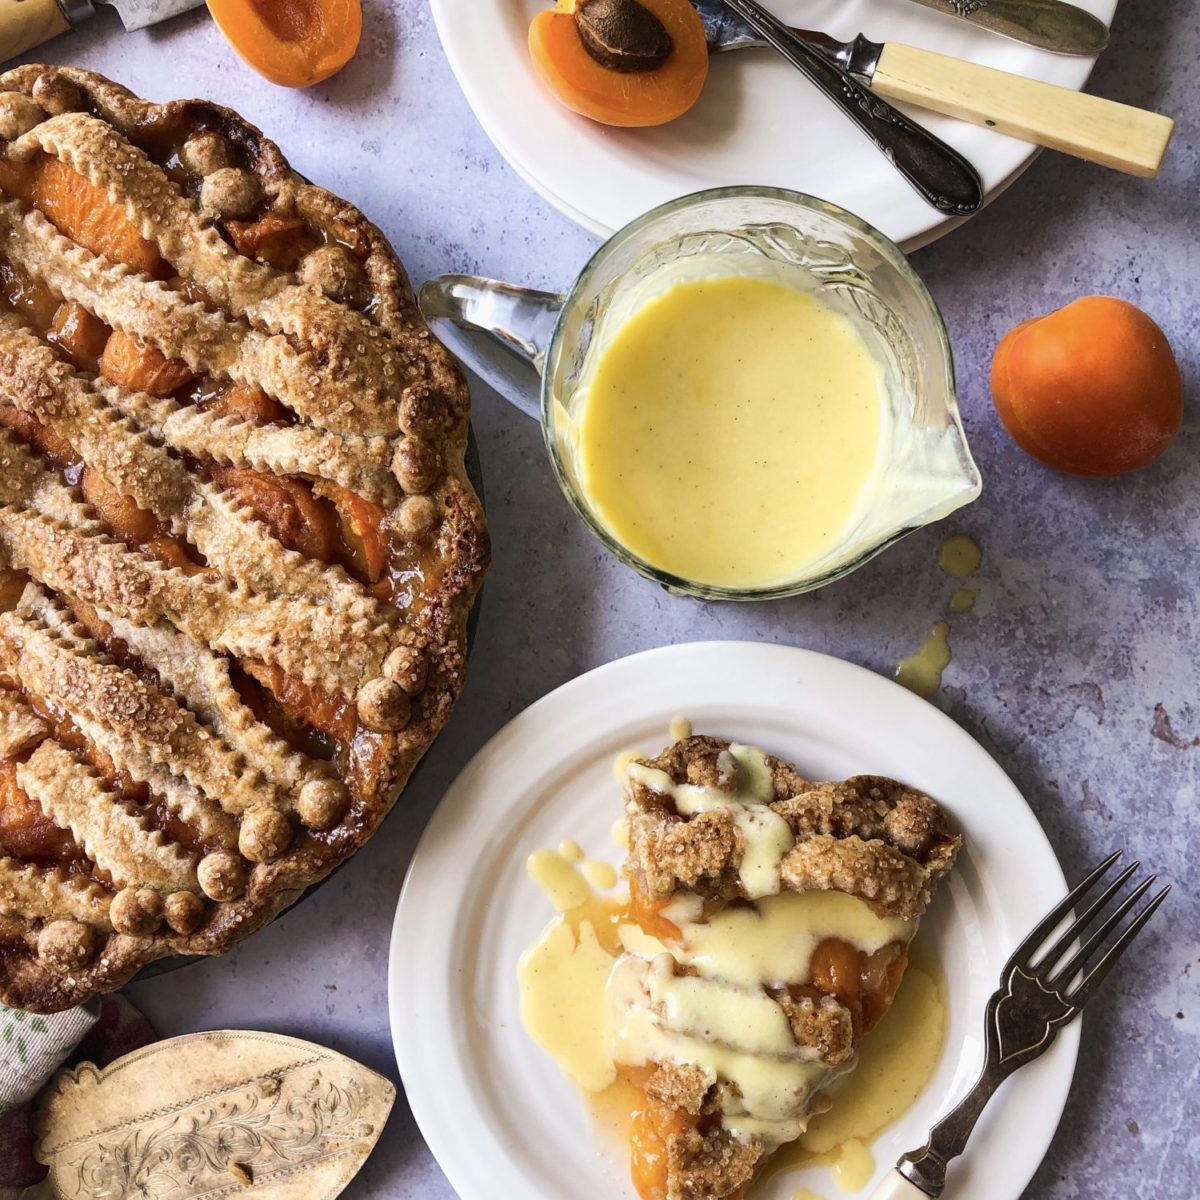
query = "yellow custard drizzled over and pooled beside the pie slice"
xmin=518 ymin=724 xmax=944 ymax=1184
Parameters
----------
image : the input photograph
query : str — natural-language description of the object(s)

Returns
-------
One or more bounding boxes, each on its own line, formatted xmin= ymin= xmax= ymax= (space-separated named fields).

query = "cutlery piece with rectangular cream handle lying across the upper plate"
xmin=692 ymin=0 xmax=1175 ymax=179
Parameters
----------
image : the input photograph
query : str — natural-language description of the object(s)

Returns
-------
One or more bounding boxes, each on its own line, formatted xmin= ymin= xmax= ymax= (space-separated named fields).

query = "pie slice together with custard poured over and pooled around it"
xmin=520 ymin=724 xmax=956 ymax=1200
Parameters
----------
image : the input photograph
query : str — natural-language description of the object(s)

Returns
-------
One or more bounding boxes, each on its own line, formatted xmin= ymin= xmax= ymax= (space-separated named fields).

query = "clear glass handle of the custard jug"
xmin=418 ymin=275 xmax=566 ymax=420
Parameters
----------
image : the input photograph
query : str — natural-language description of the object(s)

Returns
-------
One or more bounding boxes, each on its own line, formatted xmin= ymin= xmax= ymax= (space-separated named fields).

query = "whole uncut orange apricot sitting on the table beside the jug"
xmin=991 ymin=296 xmax=1183 ymax=475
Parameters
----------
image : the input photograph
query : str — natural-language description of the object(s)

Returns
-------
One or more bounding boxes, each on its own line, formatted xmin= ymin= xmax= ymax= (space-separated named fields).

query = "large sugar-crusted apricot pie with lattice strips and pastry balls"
xmin=0 ymin=66 xmax=487 ymax=1010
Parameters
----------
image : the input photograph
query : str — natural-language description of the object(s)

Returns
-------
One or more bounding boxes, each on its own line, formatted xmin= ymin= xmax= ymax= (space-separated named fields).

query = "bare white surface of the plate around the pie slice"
xmin=389 ymin=642 xmax=1079 ymax=1200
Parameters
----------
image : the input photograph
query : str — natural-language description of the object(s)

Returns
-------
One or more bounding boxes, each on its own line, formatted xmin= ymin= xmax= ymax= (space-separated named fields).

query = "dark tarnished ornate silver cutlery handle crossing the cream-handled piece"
xmin=725 ymin=0 xmax=983 ymax=216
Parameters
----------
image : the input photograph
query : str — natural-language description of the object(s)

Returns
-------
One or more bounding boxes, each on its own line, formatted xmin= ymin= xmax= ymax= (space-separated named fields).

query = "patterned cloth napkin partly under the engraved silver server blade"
xmin=0 ymin=996 xmax=157 ymax=1200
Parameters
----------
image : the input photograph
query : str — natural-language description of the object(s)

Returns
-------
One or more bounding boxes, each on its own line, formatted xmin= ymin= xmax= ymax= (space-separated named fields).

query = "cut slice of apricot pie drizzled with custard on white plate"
xmin=607 ymin=737 xmax=960 ymax=1200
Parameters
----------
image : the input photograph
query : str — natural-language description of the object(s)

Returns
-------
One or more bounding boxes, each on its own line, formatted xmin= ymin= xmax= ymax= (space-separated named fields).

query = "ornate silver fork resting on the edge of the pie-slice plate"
xmin=871 ymin=850 xmax=1171 ymax=1200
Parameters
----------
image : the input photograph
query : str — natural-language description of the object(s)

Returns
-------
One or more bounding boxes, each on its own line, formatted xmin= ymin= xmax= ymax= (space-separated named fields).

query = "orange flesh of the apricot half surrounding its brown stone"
xmin=529 ymin=0 xmax=708 ymax=127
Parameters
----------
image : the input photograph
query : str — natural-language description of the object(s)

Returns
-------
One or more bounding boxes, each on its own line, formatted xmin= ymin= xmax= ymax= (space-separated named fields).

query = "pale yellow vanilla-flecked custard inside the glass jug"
xmin=576 ymin=275 xmax=887 ymax=588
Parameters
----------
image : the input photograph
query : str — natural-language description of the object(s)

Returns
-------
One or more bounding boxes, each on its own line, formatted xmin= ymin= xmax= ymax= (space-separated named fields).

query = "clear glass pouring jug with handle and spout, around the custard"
xmin=420 ymin=187 xmax=982 ymax=600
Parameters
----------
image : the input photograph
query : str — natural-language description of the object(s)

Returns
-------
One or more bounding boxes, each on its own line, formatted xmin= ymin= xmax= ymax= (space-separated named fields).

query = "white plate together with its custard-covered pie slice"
xmin=389 ymin=642 xmax=1079 ymax=1200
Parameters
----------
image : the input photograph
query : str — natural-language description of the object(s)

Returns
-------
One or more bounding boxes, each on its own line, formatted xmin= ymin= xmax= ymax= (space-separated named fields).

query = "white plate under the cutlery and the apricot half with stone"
xmin=432 ymin=0 xmax=1116 ymax=250
